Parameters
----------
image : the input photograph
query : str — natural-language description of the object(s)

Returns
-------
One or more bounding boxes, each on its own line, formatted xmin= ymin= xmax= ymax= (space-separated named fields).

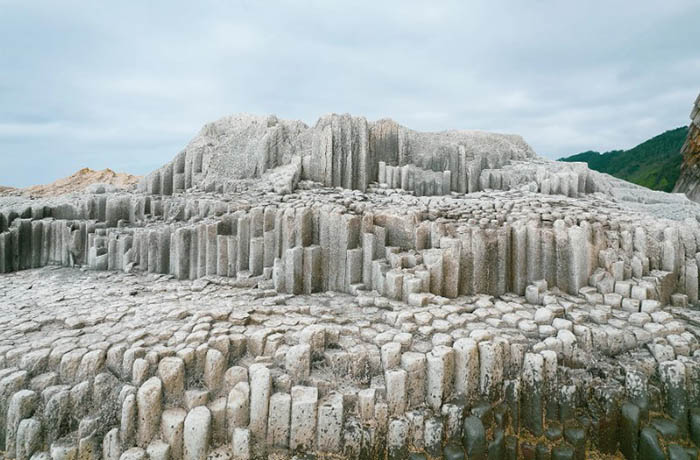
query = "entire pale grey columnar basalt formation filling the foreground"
xmin=0 ymin=115 xmax=700 ymax=460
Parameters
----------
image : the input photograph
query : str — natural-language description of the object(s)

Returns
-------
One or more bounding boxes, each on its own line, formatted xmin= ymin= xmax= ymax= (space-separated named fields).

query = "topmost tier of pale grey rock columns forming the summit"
xmin=141 ymin=114 xmax=535 ymax=195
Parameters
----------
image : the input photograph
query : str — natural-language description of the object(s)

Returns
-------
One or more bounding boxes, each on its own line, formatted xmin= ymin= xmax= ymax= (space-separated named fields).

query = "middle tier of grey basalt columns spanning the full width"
xmin=0 ymin=189 xmax=700 ymax=303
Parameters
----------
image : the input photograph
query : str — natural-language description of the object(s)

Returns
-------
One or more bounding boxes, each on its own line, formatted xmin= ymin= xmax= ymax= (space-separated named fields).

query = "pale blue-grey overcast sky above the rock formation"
xmin=0 ymin=0 xmax=700 ymax=186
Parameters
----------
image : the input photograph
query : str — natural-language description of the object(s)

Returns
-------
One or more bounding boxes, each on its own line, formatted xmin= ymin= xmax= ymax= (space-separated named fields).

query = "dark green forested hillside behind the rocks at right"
xmin=559 ymin=126 xmax=688 ymax=192
